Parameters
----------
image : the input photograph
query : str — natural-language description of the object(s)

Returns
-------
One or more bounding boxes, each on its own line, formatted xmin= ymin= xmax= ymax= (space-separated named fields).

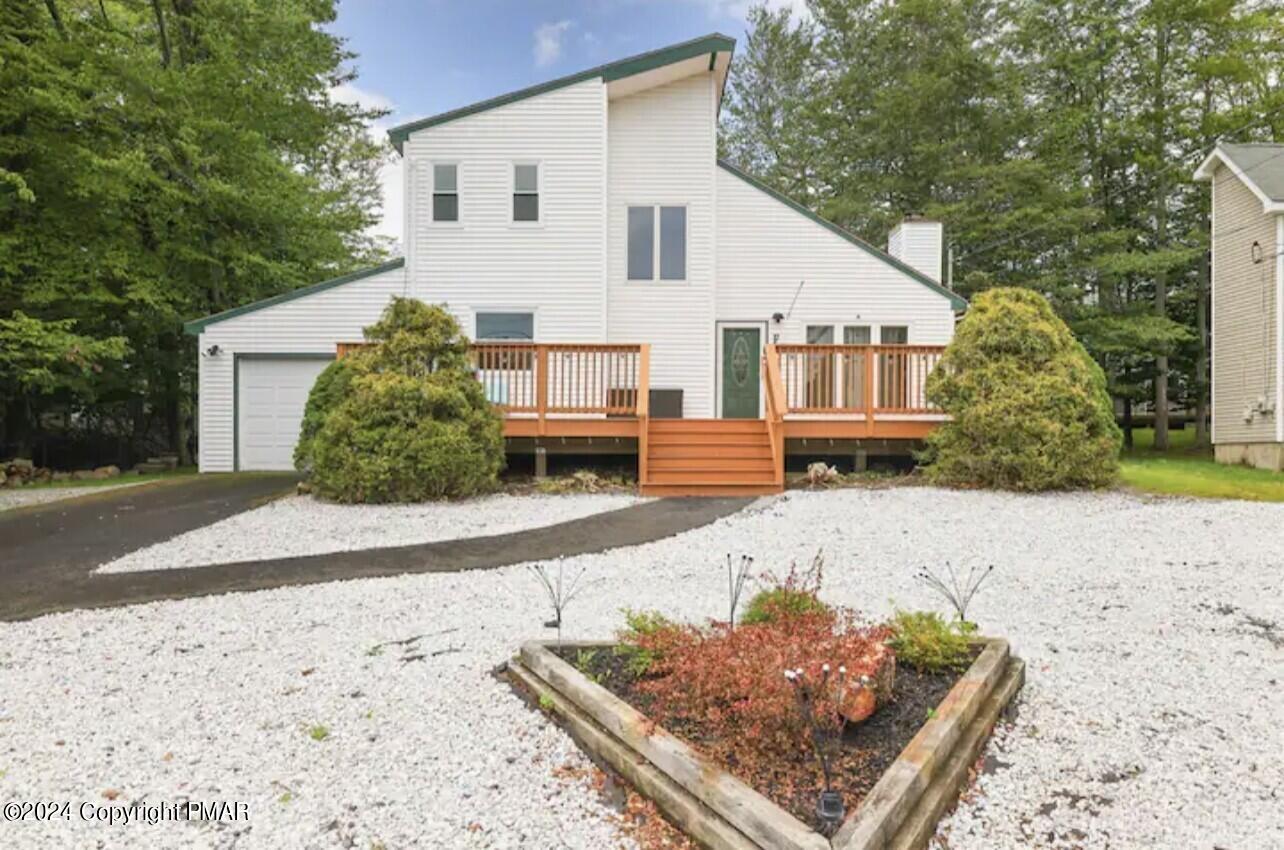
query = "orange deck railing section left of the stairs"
xmin=336 ymin=343 xmax=650 ymax=420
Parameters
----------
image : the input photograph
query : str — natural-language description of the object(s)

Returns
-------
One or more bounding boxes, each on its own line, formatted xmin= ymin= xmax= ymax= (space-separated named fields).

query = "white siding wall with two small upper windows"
xmin=404 ymin=80 xmax=606 ymax=342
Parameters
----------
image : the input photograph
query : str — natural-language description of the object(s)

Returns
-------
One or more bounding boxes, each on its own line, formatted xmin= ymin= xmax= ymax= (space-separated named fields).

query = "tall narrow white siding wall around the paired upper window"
xmin=607 ymin=73 xmax=718 ymax=417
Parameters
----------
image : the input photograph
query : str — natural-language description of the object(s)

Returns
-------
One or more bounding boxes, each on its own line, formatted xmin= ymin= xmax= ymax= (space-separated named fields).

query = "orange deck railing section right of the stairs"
xmin=767 ymin=345 xmax=945 ymax=417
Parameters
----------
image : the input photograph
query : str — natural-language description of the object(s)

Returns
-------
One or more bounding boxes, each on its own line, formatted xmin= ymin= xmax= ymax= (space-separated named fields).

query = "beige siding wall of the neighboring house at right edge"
xmin=1212 ymin=167 xmax=1281 ymax=443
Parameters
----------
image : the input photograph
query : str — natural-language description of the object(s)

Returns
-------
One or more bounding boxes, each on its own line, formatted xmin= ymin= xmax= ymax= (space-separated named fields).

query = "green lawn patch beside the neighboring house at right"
xmin=1120 ymin=428 xmax=1284 ymax=502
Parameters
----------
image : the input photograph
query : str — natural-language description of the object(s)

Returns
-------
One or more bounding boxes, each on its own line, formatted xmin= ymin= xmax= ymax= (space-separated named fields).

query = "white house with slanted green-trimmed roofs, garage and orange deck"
xmin=187 ymin=35 xmax=966 ymax=492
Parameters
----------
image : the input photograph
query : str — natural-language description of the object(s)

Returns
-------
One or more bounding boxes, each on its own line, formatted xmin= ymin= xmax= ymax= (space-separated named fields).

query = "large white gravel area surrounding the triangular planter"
xmin=0 ymin=489 xmax=1284 ymax=850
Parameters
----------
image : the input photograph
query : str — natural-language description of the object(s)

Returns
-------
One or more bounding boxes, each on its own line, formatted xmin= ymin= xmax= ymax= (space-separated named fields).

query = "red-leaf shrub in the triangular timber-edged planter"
xmin=637 ymin=609 xmax=891 ymax=770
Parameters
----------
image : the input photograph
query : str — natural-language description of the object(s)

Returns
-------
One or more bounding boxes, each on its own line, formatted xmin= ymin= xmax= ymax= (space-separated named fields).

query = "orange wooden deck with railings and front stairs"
xmin=338 ymin=343 xmax=944 ymax=496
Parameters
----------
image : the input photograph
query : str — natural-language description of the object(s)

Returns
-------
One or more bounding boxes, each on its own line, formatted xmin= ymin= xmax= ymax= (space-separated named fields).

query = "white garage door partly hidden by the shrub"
xmin=236 ymin=357 xmax=333 ymax=470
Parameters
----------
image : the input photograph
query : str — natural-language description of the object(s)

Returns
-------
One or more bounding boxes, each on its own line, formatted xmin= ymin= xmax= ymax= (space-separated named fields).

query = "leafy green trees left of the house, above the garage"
xmin=0 ymin=0 xmax=385 ymax=462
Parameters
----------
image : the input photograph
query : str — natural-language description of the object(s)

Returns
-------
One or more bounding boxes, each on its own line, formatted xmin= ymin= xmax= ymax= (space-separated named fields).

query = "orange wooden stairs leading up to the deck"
xmin=638 ymin=419 xmax=783 ymax=496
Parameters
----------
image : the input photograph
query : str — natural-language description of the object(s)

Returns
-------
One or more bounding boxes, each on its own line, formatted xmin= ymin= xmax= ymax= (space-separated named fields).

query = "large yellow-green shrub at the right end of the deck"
xmin=921 ymin=289 xmax=1121 ymax=490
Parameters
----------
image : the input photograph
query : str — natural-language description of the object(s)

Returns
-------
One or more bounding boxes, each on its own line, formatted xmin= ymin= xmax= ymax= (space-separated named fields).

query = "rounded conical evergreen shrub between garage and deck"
xmin=308 ymin=299 xmax=503 ymax=502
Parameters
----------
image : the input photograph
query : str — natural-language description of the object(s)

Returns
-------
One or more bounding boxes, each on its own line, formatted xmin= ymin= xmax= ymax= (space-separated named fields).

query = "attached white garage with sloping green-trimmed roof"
xmin=186 ymin=259 xmax=406 ymax=473
